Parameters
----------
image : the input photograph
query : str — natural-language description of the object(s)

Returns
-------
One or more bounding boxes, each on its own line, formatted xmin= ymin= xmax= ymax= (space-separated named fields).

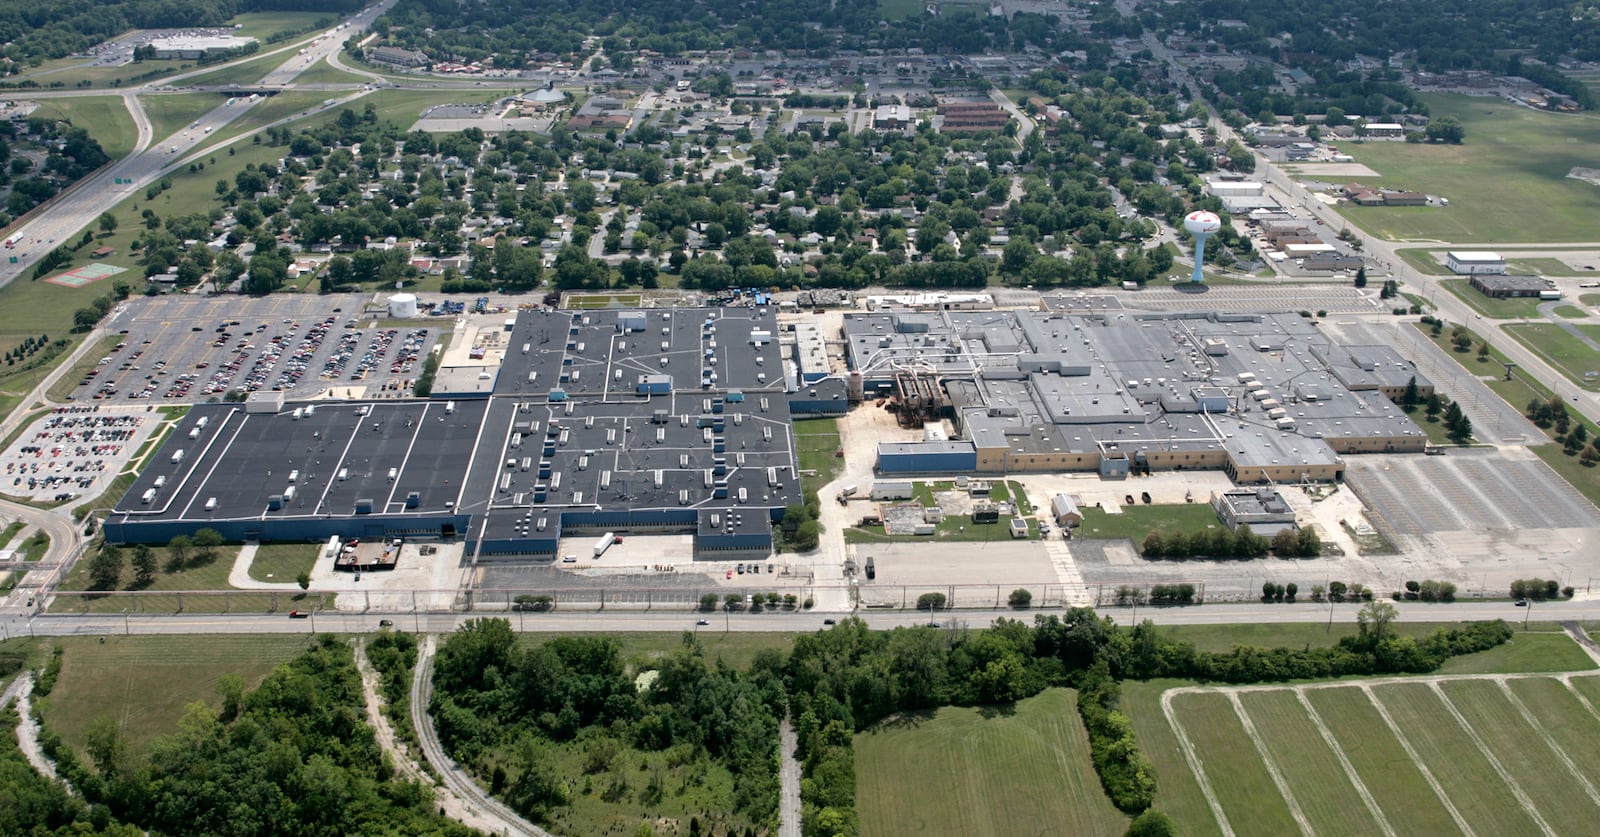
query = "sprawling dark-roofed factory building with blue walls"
xmin=106 ymin=309 xmax=800 ymax=559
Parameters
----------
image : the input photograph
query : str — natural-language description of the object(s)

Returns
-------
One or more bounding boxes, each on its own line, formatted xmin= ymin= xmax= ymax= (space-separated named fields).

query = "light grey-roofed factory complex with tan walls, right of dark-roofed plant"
xmin=845 ymin=310 xmax=1432 ymax=483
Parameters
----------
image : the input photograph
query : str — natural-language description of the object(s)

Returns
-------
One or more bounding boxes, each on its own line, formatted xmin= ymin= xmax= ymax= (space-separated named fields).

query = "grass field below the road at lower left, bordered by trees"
xmin=40 ymin=635 xmax=318 ymax=754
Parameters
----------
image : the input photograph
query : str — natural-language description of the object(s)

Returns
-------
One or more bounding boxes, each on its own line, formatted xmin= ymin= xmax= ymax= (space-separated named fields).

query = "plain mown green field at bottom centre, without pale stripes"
xmin=856 ymin=688 xmax=1128 ymax=837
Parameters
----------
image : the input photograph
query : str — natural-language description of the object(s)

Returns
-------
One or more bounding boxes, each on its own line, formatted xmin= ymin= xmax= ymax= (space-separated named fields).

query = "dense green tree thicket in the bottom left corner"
xmin=40 ymin=635 xmax=472 ymax=835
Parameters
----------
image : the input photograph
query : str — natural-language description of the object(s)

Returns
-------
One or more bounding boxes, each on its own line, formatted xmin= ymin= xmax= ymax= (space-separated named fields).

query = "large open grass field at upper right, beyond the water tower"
xmin=1339 ymin=94 xmax=1600 ymax=243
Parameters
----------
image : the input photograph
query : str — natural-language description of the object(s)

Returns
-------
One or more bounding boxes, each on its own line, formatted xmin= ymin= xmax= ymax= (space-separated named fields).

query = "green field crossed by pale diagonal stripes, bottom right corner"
xmin=1130 ymin=672 xmax=1600 ymax=835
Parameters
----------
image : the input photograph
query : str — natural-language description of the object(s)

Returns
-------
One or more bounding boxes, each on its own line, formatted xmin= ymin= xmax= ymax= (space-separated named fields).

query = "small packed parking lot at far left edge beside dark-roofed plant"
xmin=0 ymin=406 xmax=162 ymax=503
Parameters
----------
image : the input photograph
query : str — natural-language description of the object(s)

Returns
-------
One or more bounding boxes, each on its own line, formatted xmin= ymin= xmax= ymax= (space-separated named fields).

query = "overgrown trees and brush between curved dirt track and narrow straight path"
xmin=429 ymin=619 xmax=787 ymax=835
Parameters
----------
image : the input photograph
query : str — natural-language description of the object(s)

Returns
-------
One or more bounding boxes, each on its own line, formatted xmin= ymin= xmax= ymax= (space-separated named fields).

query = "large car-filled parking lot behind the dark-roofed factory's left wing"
xmin=72 ymin=294 xmax=438 ymax=403
